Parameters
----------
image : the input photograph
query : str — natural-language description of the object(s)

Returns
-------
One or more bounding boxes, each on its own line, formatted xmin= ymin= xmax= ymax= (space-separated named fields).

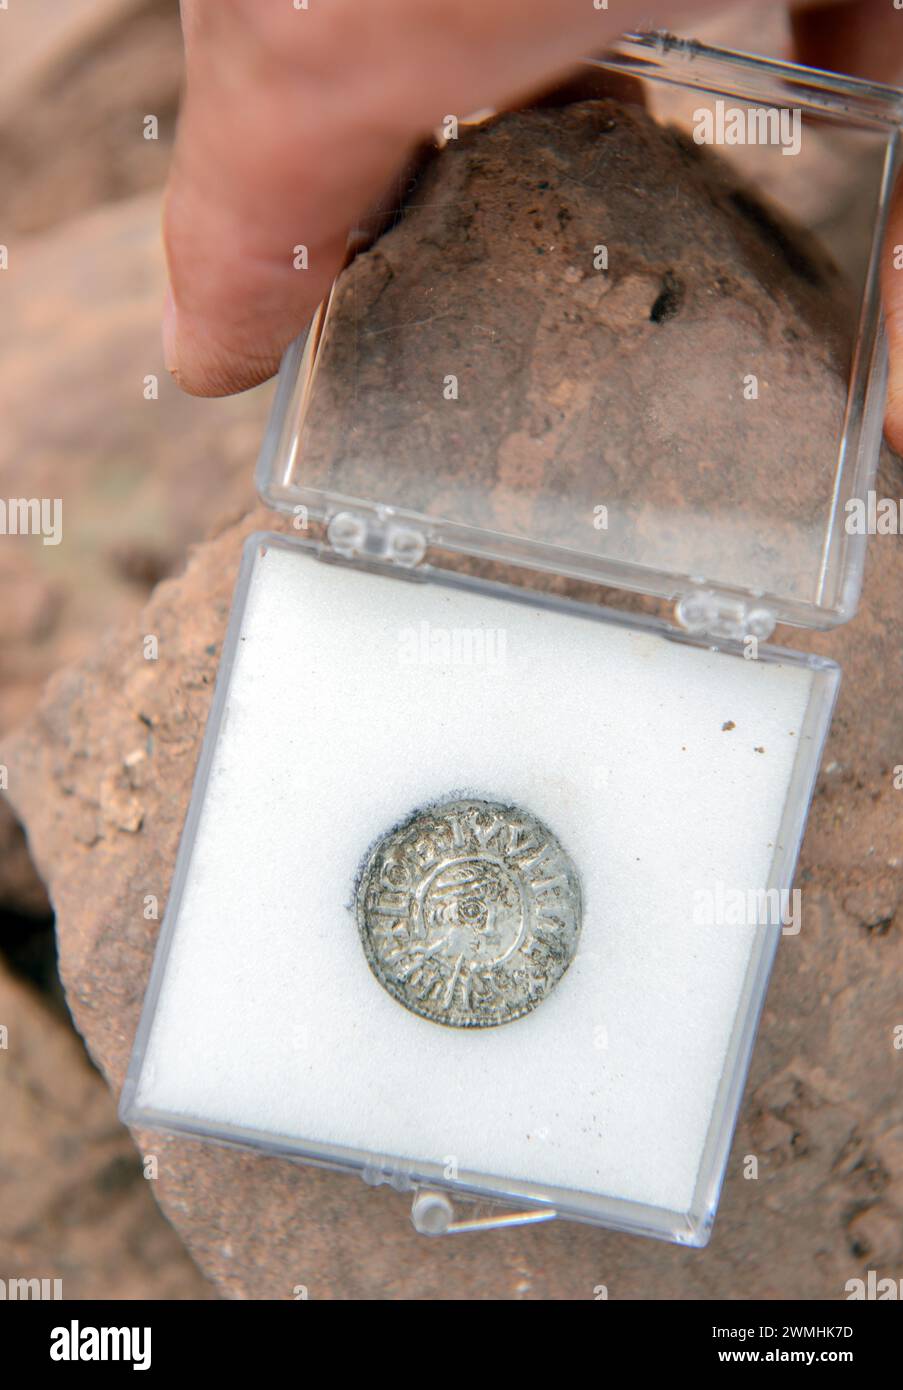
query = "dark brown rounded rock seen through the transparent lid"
xmin=300 ymin=100 xmax=853 ymax=598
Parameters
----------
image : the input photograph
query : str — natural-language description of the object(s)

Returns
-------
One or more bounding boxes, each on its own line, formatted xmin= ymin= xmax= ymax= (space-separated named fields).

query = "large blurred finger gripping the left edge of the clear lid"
xmin=164 ymin=0 xmax=709 ymax=395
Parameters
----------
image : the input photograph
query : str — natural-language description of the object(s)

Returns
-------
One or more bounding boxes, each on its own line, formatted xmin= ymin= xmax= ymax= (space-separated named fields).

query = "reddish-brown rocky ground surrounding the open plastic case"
xmin=0 ymin=0 xmax=903 ymax=1300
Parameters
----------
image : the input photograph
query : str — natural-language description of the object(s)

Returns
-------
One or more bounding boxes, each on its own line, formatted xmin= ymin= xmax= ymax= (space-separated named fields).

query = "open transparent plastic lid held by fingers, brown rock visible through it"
xmin=258 ymin=36 xmax=903 ymax=632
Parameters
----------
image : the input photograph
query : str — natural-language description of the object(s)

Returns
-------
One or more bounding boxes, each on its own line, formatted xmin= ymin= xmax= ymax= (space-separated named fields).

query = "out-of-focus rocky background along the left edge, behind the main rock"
xmin=0 ymin=0 xmax=268 ymax=1298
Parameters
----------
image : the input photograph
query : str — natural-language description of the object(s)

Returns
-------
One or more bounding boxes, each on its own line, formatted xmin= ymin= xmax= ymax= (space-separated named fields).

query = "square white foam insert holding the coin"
xmin=136 ymin=546 xmax=813 ymax=1211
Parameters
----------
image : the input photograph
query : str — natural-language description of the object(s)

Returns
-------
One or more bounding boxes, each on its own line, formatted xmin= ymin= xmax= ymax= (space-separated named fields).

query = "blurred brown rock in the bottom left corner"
xmin=0 ymin=966 xmax=213 ymax=1300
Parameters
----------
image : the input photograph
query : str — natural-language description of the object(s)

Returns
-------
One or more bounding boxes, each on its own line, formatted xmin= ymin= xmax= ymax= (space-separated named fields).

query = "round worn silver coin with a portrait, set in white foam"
xmin=357 ymin=799 xmax=581 ymax=1029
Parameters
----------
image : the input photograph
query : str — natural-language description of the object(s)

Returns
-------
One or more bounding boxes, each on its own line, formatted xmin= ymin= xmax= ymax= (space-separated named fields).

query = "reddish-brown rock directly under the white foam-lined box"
xmin=4 ymin=460 xmax=903 ymax=1300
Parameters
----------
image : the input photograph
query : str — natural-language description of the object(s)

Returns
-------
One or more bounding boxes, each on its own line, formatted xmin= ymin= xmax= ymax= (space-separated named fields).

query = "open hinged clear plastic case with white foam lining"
xmin=122 ymin=36 xmax=900 ymax=1244
